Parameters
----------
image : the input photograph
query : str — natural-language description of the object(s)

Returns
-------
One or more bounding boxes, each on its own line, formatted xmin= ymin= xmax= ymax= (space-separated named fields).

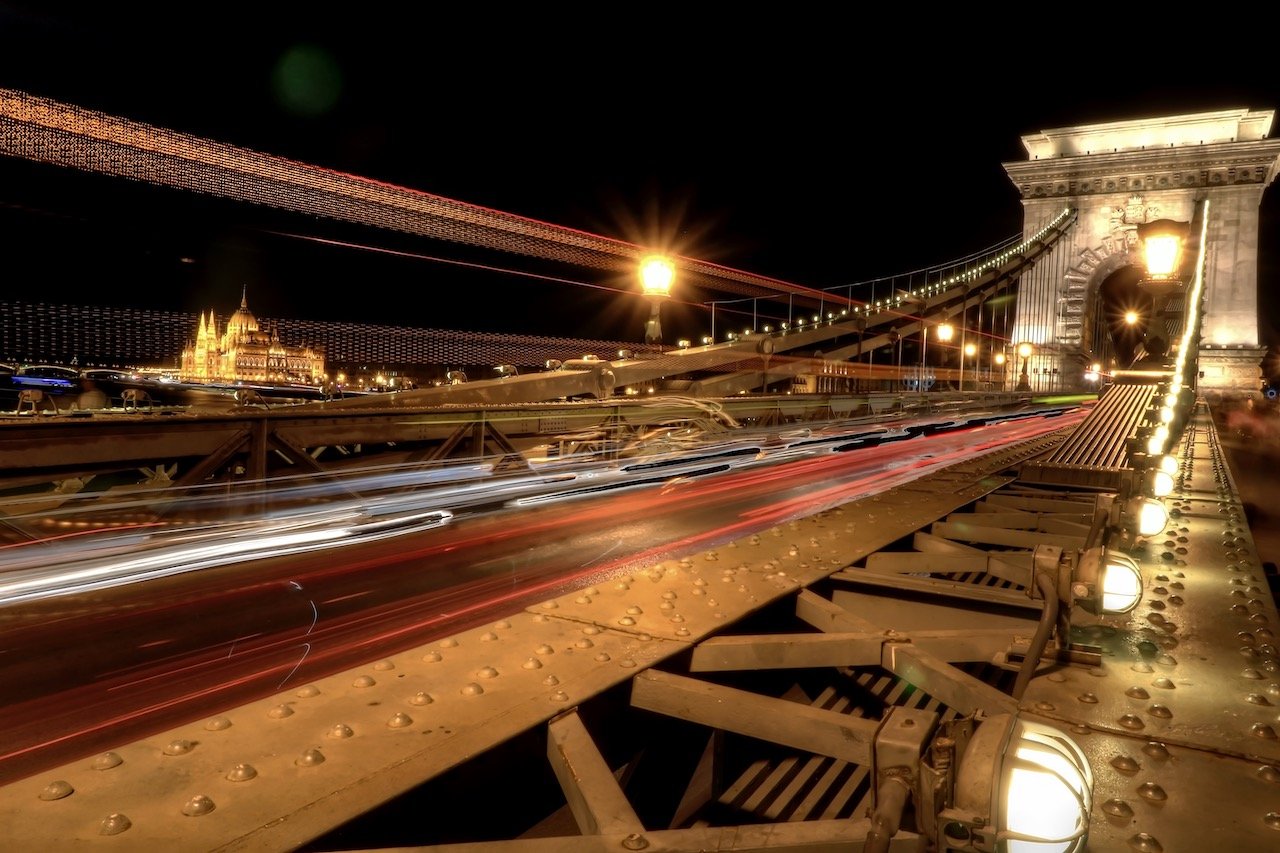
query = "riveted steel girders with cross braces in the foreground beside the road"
xmin=0 ymin=399 xmax=1280 ymax=850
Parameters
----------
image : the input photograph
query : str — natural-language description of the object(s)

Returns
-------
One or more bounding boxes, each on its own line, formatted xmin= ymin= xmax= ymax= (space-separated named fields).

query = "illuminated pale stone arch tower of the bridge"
xmin=1004 ymin=109 xmax=1280 ymax=397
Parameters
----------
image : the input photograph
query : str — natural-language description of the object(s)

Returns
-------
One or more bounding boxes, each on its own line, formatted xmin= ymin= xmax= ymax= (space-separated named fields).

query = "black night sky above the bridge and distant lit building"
xmin=0 ymin=4 xmax=1280 ymax=348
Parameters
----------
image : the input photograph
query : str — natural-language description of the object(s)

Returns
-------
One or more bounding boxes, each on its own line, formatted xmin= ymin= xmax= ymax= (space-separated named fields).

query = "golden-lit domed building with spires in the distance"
xmin=178 ymin=292 xmax=326 ymax=386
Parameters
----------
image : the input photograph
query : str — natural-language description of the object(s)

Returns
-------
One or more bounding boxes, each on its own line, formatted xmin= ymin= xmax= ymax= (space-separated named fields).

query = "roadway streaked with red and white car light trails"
xmin=0 ymin=402 xmax=1083 ymax=776
